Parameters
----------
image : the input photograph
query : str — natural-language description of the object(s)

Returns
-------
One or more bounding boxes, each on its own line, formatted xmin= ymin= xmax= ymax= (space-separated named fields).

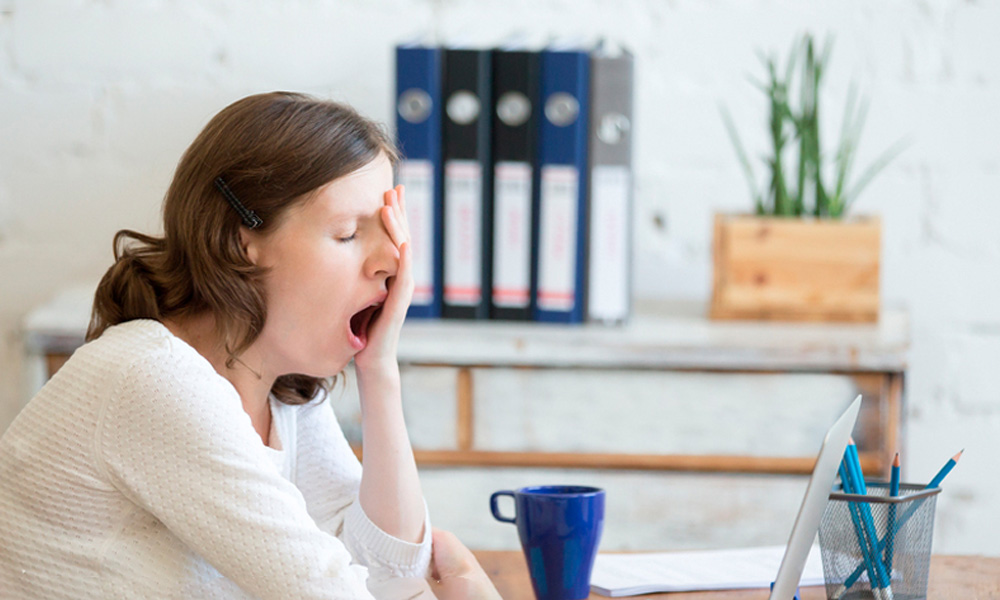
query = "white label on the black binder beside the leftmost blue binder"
xmin=444 ymin=160 xmax=483 ymax=306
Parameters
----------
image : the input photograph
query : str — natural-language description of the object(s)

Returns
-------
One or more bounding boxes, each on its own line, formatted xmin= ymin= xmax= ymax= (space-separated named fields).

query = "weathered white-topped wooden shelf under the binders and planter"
xmin=24 ymin=288 xmax=909 ymax=474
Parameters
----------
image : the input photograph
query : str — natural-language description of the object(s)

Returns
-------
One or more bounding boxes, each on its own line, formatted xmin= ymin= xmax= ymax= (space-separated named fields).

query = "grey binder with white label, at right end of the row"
xmin=586 ymin=44 xmax=633 ymax=323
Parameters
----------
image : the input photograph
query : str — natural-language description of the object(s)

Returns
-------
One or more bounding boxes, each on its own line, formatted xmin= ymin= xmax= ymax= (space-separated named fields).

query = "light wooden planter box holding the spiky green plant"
xmin=709 ymin=215 xmax=881 ymax=322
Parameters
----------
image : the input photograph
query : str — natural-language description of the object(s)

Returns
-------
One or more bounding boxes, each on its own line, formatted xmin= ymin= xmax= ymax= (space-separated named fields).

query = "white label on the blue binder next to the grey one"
xmin=538 ymin=165 xmax=580 ymax=311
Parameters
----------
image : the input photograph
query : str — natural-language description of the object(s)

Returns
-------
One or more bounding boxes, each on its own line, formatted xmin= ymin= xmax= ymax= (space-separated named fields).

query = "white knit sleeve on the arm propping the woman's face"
xmin=295 ymin=394 xmax=431 ymax=595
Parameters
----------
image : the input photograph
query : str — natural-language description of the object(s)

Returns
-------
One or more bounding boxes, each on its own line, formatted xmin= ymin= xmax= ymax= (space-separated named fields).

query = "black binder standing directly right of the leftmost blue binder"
xmin=441 ymin=48 xmax=493 ymax=319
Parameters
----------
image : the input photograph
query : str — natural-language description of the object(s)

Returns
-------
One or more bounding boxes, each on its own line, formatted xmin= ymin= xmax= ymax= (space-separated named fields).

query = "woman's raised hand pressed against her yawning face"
xmin=354 ymin=185 xmax=413 ymax=374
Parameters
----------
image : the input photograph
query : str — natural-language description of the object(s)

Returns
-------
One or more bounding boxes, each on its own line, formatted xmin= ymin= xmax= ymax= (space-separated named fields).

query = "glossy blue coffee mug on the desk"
xmin=490 ymin=485 xmax=604 ymax=600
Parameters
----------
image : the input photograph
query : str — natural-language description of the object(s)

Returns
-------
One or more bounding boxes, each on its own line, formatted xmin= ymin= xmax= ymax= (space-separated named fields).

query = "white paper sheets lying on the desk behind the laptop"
xmin=590 ymin=546 xmax=823 ymax=597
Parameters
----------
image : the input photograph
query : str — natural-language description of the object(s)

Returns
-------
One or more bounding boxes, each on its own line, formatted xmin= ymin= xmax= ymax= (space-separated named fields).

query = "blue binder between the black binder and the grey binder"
xmin=535 ymin=47 xmax=590 ymax=323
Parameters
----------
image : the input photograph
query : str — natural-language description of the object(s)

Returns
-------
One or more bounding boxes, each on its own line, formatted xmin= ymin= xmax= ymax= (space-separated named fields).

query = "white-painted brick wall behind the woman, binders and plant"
xmin=0 ymin=0 xmax=1000 ymax=555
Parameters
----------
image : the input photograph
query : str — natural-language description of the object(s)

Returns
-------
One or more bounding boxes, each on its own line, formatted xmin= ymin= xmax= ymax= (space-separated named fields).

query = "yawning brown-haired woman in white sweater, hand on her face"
xmin=0 ymin=93 xmax=495 ymax=598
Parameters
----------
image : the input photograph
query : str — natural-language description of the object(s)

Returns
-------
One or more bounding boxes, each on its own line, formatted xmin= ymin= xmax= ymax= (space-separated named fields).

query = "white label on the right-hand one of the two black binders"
xmin=493 ymin=162 xmax=531 ymax=308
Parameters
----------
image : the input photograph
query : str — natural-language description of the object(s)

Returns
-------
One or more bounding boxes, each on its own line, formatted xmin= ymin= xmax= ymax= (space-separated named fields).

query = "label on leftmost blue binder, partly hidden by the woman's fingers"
xmin=399 ymin=159 xmax=434 ymax=304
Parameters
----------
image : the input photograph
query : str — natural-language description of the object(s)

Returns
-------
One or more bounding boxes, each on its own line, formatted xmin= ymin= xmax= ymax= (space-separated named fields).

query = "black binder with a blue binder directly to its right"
xmin=490 ymin=48 xmax=539 ymax=320
